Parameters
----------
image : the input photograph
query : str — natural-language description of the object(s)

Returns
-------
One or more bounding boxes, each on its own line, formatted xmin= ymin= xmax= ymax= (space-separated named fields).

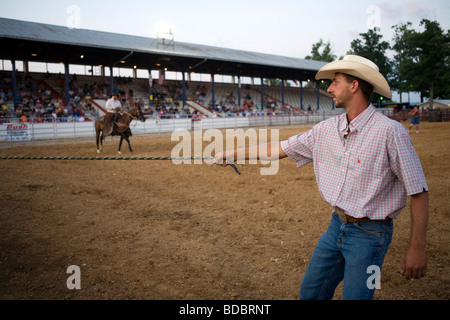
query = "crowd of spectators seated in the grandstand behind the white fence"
xmin=0 ymin=72 xmax=324 ymax=122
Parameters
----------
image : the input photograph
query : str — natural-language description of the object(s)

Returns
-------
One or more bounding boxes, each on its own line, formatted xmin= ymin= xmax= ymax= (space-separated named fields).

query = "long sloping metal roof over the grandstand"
xmin=0 ymin=18 xmax=326 ymax=81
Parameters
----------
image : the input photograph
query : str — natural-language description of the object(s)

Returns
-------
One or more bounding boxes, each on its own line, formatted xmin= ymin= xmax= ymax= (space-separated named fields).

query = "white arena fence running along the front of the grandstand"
xmin=0 ymin=109 xmax=450 ymax=146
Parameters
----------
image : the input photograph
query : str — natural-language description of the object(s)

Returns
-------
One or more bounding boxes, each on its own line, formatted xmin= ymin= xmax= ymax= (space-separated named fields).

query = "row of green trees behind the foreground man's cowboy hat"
xmin=305 ymin=19 xmax=450 ymax=107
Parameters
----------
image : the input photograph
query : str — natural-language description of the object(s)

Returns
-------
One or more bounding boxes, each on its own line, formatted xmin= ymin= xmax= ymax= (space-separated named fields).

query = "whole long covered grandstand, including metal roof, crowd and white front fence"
xmin=0 ymin=18 xmax=342 ymax=143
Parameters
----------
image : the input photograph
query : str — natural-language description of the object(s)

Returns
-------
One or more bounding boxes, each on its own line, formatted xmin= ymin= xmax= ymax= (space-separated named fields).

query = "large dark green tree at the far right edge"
xmin=392 ymin=19 xmax=450 ymax=108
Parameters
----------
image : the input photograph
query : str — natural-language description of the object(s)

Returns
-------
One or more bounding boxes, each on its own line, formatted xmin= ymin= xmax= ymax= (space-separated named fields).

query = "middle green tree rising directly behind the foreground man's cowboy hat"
xmin=347 ymin=28 xmax=393 ymax=102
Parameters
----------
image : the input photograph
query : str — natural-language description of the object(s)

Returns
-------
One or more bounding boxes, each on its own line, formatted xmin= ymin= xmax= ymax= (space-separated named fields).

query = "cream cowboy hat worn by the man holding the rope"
xmin=316 ymin=54 xmax=392 ymax=99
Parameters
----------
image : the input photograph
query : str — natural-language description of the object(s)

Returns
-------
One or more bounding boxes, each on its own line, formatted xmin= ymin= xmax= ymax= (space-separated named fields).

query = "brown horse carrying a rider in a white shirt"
xmin=95 ymin=105 xmax=145 ymax=154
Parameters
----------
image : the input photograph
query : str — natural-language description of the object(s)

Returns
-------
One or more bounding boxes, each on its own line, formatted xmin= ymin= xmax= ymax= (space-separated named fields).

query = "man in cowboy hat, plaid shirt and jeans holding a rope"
xmin=215 ymin=55 xmax=429 ymax=300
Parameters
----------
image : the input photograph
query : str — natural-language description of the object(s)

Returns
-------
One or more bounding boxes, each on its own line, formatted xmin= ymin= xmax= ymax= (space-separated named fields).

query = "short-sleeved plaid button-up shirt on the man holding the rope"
xmin=281 ymin=105 xmax=428 ymax=219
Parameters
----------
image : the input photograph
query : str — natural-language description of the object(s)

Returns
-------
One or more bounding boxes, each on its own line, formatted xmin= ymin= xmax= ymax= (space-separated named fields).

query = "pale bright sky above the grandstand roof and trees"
xmin=0 ymin=0 xmax=450 ymax=102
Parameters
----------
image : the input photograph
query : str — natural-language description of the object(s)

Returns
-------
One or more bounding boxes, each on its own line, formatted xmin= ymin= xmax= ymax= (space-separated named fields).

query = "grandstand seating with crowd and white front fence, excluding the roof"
xmin=0 ymin=72 xmax=341 ymax=146
